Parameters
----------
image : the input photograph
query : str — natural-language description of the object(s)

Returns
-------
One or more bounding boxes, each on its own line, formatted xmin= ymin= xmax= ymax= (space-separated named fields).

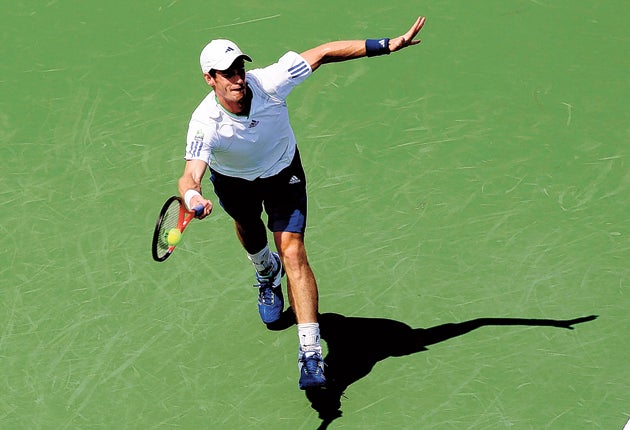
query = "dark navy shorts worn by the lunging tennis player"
xmin=210 ymin=148 xmax=307 ymax=233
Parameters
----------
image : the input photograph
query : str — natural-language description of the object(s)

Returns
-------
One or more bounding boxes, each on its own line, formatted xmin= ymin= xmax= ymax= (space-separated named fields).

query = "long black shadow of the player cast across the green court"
xmin=269 ymin=308 xmax=597 ymax=429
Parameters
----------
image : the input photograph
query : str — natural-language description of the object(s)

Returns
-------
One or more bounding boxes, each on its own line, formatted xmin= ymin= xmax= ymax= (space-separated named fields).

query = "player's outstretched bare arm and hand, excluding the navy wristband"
xmin=300 ymin=16 xmax=425 ymax=71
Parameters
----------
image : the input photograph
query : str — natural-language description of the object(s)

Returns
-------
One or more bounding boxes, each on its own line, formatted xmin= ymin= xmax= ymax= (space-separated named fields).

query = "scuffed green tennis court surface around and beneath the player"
xmin=0 ymin=0 xmax=630 ymax=430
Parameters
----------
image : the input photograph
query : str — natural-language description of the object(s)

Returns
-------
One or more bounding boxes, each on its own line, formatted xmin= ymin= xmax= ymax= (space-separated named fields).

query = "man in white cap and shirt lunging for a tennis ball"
xmin=179 ymin=17 xmax=425 ymax=389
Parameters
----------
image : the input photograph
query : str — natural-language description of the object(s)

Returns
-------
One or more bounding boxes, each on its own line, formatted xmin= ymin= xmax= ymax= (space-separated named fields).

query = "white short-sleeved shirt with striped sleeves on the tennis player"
xmin=185 ymin=52 xmax=312 ymax=180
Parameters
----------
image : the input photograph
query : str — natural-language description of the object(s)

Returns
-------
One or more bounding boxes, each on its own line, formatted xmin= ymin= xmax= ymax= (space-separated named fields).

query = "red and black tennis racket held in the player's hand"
xmin=151 ymin=196 xmax=203 ymax=261
